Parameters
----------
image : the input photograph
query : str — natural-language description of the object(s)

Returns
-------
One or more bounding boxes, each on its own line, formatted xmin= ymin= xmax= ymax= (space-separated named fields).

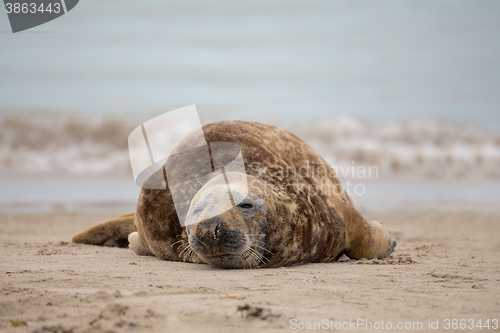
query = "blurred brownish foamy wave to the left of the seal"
xmin=0 ymin=117 xmax=135 ymax=176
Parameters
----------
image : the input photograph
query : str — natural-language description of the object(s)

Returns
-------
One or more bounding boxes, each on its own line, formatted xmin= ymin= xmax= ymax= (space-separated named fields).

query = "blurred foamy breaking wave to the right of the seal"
xmin=290 ymin=117 xmax=500 ymax=178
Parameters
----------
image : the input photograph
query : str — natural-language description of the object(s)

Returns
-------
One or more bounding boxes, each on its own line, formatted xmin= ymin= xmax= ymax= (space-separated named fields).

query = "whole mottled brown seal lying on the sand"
xmin=73 ymin=121 xmax=396 ymax=268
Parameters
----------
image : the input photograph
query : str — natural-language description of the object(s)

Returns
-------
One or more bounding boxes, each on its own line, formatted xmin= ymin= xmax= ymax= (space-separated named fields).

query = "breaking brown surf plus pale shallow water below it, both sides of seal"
xmin=0 ymin=116 xmax=500 ymax=212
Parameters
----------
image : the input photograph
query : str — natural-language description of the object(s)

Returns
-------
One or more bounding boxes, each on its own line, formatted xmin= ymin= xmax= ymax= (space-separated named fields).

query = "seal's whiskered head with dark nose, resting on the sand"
xmin=187 ymin=174 xmax=290 ymax=268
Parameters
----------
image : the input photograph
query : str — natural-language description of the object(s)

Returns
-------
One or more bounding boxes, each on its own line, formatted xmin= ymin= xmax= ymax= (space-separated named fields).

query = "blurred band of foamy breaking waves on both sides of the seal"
xmin=0 ymin=116 xmax=500 ymax=178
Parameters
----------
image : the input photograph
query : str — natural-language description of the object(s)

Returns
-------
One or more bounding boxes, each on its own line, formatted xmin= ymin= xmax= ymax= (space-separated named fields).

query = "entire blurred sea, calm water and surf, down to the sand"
xmin=0 ymin=0 xmax=500 ymax=211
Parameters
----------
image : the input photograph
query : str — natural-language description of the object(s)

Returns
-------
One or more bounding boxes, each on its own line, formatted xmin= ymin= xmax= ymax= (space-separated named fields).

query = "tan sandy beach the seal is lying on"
xmin=0 ymin=211 xmax=500 ymax=333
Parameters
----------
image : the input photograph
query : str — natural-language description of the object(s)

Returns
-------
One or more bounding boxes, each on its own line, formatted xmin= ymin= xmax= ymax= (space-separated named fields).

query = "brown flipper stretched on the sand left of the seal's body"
xmin=71 ymin=212 xmax=137 ymax=247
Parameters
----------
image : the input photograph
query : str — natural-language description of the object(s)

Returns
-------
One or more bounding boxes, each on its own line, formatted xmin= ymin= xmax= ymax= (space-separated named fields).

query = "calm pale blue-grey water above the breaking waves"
xmin=0 ymin=0 xmax=500 ymax=127
